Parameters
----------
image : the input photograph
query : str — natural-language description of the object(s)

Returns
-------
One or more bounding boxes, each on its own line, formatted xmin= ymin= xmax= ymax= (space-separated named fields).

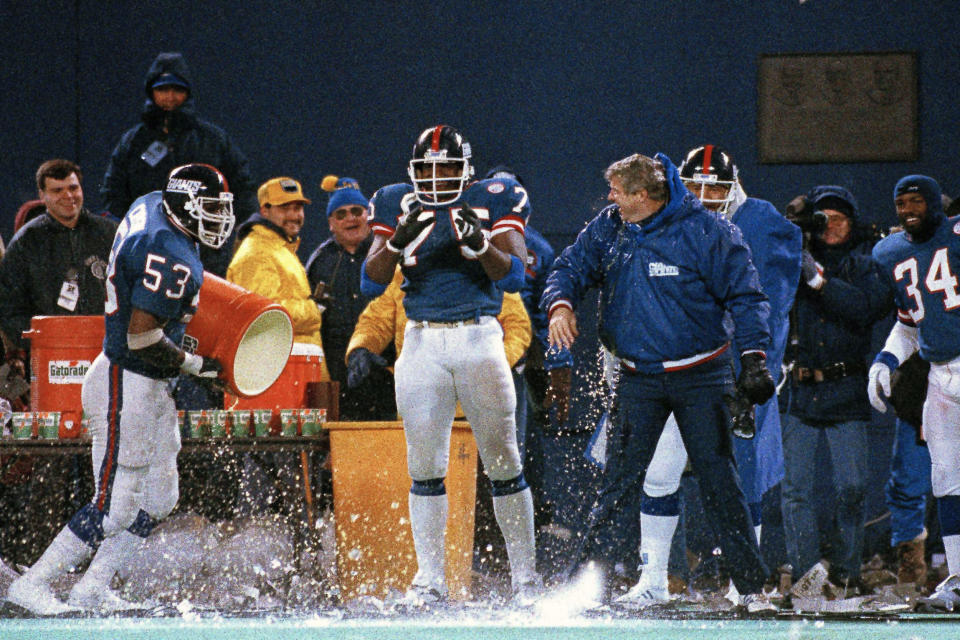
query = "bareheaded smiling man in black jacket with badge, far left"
xmin=0 ymin=159 xmax=117 ymax=564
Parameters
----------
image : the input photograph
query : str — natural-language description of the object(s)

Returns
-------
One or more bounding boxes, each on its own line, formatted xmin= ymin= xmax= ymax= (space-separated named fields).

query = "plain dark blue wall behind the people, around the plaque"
xmin=0 ymin=0 xmax=960 ymax=256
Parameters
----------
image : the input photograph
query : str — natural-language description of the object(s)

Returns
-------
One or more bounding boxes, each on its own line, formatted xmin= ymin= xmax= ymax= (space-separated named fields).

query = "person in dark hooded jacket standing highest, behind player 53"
xmin=100 ymin=53 xmax=258 ymax=277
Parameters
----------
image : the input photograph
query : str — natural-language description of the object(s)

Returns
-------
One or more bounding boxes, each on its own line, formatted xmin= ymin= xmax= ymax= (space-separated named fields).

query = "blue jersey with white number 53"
xmin=103 ymin=191 xmax=203 ymax=379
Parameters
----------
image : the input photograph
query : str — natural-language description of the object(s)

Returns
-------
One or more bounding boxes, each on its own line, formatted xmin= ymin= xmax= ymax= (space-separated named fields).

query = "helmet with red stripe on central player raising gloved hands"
xmin=407 ymin=125 xmax=473 ymax=206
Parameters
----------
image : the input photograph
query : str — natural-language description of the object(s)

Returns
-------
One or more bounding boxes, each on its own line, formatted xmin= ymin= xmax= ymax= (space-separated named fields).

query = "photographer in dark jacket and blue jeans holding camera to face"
xmin=780 ymin=185 xmax=890 ymax=593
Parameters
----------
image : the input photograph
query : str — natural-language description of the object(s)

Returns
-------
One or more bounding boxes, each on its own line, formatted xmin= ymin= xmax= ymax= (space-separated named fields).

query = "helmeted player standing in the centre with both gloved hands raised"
xmin=361 ymin=125 xmax=539 ymax=607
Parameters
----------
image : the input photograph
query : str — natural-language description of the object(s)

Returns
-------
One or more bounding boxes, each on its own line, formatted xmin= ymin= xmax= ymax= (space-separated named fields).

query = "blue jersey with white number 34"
xmin=873 ymin=216 xmax=960 ymax=362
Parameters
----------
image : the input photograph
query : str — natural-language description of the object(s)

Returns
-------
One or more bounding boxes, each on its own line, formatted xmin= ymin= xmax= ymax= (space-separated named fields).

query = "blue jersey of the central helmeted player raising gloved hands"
xmin=370 ymin=178 xmax=530 ymax=322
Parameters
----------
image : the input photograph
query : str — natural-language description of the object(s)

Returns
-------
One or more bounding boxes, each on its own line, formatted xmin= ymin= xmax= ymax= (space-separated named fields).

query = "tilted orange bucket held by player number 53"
xmin=183 ymin=272 xmax=293 ymax=398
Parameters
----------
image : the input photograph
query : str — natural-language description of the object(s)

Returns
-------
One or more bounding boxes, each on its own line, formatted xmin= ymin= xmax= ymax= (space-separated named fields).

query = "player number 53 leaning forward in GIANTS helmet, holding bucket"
xmin=7 ymin=164 xmax=234 ymax=615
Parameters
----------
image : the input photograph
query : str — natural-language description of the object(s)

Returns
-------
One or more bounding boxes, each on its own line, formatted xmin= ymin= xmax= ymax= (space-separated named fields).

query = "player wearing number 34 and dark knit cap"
xmin=867 ymin=175 xmax=960 ymax=604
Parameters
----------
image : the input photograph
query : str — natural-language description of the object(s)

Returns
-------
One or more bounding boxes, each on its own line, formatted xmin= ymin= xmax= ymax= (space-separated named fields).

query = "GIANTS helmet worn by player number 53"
xmin=163 ymin=164 xmax=234 ymax=249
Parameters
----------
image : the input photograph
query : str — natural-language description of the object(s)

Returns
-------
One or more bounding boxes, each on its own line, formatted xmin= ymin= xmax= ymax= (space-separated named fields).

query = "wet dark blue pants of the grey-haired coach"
xmin=573 ymin=357 xmax=767 ymax=594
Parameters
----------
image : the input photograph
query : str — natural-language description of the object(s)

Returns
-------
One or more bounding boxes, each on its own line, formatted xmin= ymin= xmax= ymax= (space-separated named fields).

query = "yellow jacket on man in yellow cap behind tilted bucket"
xmin=227 ymin=221 xmax=330 ymax=380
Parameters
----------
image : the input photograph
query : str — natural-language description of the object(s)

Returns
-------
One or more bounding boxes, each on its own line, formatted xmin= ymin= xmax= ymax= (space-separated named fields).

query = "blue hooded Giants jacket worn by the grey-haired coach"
xmin=540 ymin=154 xmax=770 ymax=373
